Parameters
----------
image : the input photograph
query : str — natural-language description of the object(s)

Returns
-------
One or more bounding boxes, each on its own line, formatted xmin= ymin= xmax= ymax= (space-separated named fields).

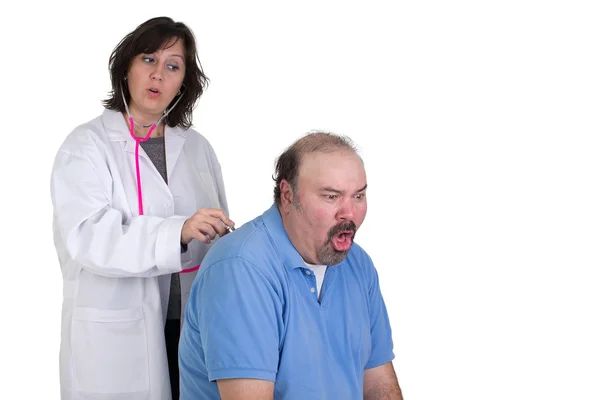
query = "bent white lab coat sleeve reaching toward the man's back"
xmin=51 ymin=151 xmax=186 ymax=277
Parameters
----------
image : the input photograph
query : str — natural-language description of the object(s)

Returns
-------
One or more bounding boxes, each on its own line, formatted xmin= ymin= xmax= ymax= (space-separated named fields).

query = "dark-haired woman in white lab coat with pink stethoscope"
xmin=51 ymin=17 xmax=233 ymax=400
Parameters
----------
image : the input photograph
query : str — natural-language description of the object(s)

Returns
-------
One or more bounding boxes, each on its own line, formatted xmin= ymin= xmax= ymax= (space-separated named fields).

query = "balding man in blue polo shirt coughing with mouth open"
xmin=179 ymin=132 xmax=402 ymax=400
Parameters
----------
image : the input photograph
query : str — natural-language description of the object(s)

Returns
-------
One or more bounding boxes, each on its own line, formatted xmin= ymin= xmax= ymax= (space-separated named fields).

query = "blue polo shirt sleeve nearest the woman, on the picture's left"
xmin=196 ymin=257 xmax=283 ymax=382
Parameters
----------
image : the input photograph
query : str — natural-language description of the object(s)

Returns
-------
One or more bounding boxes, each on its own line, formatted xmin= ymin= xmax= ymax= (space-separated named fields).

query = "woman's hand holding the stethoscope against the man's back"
xmin=181 ymin=208 xmax=235 ymax=244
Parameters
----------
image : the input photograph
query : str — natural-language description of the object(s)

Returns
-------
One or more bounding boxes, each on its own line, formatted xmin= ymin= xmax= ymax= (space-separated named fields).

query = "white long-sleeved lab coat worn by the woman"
xmin=51 ymin=110 xmax=228 ymax=400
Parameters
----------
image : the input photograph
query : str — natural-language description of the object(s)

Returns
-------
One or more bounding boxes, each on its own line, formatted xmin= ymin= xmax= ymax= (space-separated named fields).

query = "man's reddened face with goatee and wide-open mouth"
xmin=282 ymin=150 xmax=367 ymax=265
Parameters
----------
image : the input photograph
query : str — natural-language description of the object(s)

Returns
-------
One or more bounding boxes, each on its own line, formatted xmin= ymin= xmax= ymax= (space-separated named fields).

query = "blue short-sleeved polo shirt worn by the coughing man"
xmin=179 ymin=205 xmax=394 ymax=400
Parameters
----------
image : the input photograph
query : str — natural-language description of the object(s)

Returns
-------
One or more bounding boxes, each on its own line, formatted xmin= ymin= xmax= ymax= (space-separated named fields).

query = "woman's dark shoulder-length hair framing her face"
xmin=102 ymin=17 xmax=208 ymax=129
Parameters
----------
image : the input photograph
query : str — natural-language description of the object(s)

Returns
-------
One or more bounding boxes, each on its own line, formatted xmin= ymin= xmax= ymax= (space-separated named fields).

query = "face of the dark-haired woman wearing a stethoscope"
xmin=127 ymin=38 xmax=185 ymax=123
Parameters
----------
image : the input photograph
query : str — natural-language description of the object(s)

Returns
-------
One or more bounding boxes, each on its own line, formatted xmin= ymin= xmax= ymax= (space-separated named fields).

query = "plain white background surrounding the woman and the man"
xmin=0 ymin=0 xmax=600 ymax=400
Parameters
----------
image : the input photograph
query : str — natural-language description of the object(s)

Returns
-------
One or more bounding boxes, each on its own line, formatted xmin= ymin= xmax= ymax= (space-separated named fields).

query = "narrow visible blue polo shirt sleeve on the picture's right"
xmin=365 ymin=267 xmax=395 ymax=369
